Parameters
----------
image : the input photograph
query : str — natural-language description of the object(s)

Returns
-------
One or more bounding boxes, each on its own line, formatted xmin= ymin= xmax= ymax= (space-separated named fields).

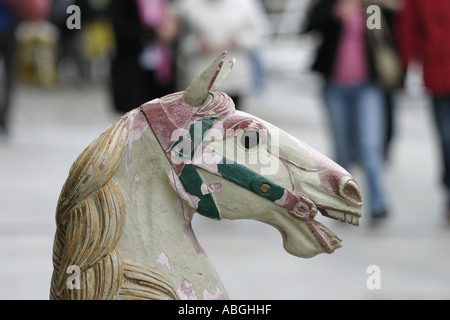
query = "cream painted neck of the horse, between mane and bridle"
xmin=114 ymin=114 xmax=226 ymax=299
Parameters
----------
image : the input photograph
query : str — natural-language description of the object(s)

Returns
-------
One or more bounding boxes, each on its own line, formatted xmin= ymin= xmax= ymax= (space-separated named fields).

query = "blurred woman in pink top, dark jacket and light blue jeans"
xmin=306 ymin=0 xmax=388 ymax=221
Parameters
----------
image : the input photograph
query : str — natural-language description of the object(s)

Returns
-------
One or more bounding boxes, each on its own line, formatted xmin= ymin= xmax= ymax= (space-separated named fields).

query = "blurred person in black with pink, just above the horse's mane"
xmin=110 ymin=0 xmax=178 ymax=112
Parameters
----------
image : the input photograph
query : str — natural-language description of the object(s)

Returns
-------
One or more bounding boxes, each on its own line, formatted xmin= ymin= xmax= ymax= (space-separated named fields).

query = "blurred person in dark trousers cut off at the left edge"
xmin=0 ymin=0 xmax=52 ymax=135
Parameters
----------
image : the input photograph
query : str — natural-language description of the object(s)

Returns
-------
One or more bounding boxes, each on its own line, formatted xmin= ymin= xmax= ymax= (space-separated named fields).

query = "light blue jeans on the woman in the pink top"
xmin=324 ymin=82 xmax=387 ymax=214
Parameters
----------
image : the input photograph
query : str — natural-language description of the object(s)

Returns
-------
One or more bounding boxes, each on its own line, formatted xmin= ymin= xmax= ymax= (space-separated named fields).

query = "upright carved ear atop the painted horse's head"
xmin=183 ymin=52 xmax=234 ymax=107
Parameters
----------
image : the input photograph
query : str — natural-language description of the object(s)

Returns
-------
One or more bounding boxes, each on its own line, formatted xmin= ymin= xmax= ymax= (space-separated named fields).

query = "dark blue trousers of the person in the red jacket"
xmin=433 ymin=95 xmax=450 ymax=208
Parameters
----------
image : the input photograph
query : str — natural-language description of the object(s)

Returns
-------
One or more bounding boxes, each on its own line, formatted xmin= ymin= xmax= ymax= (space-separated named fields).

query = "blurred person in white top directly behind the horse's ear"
xmin=177 ymin=0 xmax=268 ymax=109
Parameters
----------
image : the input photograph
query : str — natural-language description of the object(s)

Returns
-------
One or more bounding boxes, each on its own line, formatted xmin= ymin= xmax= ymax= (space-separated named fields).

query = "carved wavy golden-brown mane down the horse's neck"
xmin=50 ymin=115 xmax=177 ymax=300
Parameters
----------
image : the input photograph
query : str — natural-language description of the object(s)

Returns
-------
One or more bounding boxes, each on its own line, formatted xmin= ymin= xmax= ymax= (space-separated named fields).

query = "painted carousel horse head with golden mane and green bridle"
xmin=50 ymin=53 xmax=362 ymax=299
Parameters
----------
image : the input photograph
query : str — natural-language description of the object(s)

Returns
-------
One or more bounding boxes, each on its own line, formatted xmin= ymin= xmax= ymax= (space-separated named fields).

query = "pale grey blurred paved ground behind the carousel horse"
xmin=0 ymin=59 xmax=450 ymax=299
